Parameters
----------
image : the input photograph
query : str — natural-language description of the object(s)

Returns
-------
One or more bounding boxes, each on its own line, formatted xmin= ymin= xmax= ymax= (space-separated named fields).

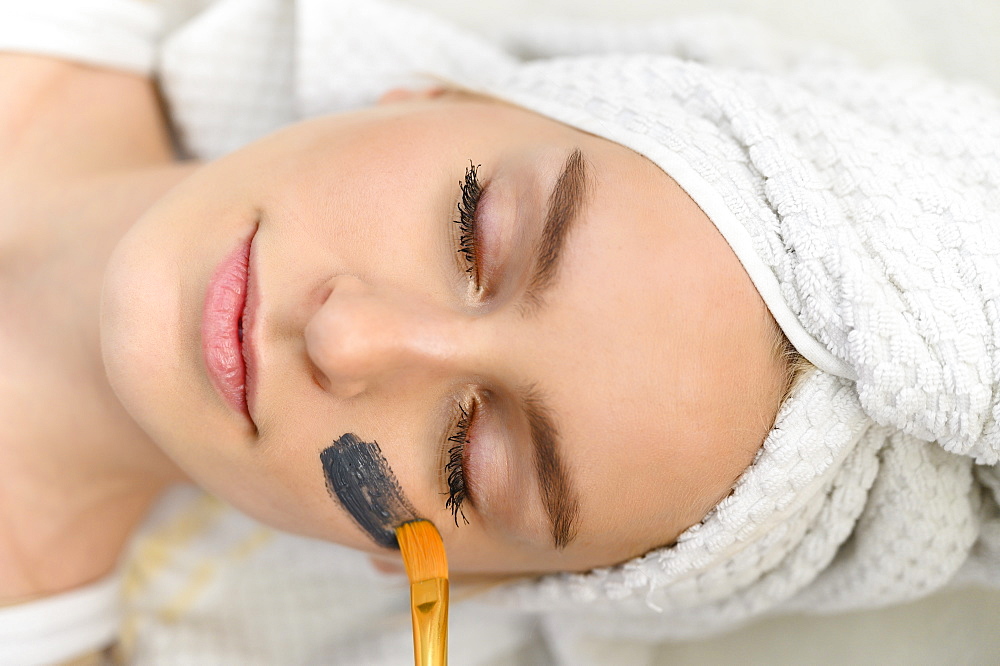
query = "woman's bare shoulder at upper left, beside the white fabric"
xmin=0 ymin=53 xmax=171 ymax=182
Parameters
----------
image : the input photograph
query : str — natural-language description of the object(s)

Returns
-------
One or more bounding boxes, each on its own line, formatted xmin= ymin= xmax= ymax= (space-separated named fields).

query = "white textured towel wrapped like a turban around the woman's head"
xmin=470 ymin=20 xmax=1000 ymax=638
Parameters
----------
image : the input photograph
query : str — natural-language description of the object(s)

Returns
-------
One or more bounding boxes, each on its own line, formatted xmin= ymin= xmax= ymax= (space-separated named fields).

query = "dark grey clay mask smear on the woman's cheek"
xmin=319 ymin=432 xmax=419 ymax=548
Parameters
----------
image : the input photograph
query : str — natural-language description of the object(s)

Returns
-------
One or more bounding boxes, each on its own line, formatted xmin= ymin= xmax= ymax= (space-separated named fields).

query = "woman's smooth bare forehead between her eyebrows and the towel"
xmin=524 ymin=135 xmax=781 ymax=561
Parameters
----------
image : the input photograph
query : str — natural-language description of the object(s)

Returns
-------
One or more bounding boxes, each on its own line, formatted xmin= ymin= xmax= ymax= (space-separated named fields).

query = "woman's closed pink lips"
xmin=201 ymin=228 xmax=257 ymax=422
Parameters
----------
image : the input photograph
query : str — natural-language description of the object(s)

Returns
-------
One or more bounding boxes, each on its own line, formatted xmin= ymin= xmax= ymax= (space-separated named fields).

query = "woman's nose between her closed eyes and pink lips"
xmin=305 ymin=276 xmax=463 ymax=398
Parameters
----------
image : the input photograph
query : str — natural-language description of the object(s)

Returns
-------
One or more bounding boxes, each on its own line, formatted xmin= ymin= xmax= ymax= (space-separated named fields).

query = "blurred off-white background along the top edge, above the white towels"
xmin=404 ymin=0 xmax=1000 ymax=90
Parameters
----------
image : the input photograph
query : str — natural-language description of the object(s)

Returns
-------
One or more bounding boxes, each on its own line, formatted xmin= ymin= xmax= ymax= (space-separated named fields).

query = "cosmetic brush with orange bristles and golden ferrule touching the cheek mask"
xmin=396 ymin=519 xmax=448 ymax=666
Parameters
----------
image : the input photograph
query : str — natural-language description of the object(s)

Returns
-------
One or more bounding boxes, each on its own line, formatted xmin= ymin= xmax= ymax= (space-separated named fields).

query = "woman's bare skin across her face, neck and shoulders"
xmin=0 ymin=54 xmax=784 ymax=599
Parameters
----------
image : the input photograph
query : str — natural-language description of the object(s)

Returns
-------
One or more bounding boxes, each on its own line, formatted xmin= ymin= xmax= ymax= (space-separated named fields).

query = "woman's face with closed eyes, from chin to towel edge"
xmin=101 ymin=93 xmax=783 ymax=573
